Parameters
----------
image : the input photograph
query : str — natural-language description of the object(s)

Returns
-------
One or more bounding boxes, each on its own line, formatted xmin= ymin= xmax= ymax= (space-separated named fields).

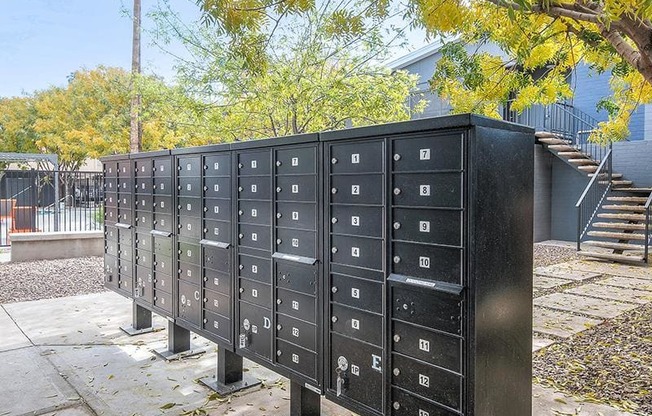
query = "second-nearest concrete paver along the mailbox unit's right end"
xmin=533 ymin=293 xmax=636 ymax=319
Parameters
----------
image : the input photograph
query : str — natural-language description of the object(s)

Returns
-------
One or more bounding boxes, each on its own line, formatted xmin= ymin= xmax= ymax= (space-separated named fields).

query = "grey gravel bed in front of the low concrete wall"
xmin=0 ymin=257 xmax=105 ymax=303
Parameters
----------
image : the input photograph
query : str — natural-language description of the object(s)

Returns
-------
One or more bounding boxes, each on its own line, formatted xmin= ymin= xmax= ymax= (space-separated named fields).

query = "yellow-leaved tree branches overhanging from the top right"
xmin=198 ymin=0 xmax=652 ymax=140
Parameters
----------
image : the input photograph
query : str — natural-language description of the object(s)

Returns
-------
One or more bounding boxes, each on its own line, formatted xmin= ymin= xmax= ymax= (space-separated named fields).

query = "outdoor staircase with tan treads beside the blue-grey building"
xmin=536 ymin=132 xmax=652 ymax=263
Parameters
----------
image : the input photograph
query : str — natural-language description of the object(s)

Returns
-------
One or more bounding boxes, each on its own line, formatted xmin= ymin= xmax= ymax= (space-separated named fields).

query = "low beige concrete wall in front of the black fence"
xmin=9 ymin=231 xmax=104 ymax=261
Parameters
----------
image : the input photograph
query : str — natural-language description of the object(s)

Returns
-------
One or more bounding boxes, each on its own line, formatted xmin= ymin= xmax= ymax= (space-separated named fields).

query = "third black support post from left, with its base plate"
xmin=199 ymin=347 xmax=260 ymax=396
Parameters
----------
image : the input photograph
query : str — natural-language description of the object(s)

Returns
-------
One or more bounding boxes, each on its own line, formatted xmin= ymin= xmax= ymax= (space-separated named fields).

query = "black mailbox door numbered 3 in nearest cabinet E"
xmin=327 ymin=205 xmax=384 ymax=238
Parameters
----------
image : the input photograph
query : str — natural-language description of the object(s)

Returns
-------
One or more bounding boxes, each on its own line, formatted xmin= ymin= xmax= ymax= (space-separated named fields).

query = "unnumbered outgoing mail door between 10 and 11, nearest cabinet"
xmin=391 ymin=287 xmax=462 ymax=335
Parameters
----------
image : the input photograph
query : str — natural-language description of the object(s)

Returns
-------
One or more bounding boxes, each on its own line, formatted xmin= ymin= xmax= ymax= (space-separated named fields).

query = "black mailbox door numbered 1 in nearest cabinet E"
xmin=329 ymin=141 xmax=385 ymax=173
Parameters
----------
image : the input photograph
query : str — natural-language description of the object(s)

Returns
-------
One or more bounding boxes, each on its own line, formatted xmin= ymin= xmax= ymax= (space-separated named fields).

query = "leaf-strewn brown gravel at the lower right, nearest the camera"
xmin=532 ymin=304 xmax=652 ymax=415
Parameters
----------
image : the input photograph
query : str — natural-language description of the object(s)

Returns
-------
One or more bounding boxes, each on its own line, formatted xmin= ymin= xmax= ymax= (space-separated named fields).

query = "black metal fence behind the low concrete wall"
xmin=0 ymin=169 xmax=104 ymax=246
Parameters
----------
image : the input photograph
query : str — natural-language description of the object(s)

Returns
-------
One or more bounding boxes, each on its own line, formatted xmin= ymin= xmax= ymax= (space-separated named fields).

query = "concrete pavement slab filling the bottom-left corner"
xmin=0 ymin=347 xmax=80 ymax=415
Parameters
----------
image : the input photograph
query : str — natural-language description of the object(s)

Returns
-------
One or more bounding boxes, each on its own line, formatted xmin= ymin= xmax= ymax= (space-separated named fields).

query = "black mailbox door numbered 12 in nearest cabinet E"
xmin=392 ymin=354 xmax=462 ymax=410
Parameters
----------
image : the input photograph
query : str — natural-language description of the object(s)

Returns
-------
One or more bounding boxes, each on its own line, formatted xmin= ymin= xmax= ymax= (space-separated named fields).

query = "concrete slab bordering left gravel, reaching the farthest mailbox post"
xmin=4 ymin=292 xmax=167 ymax=345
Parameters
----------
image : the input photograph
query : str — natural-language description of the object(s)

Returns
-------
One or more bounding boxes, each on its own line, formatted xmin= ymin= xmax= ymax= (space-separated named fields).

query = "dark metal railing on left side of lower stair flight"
xmin=575 ymin=149 xmax=612 ymax=251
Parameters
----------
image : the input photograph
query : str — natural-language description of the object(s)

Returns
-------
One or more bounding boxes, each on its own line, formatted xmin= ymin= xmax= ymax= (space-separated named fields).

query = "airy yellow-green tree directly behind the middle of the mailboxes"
xmin=150 ymin=1 xmax=425 ymax=141
